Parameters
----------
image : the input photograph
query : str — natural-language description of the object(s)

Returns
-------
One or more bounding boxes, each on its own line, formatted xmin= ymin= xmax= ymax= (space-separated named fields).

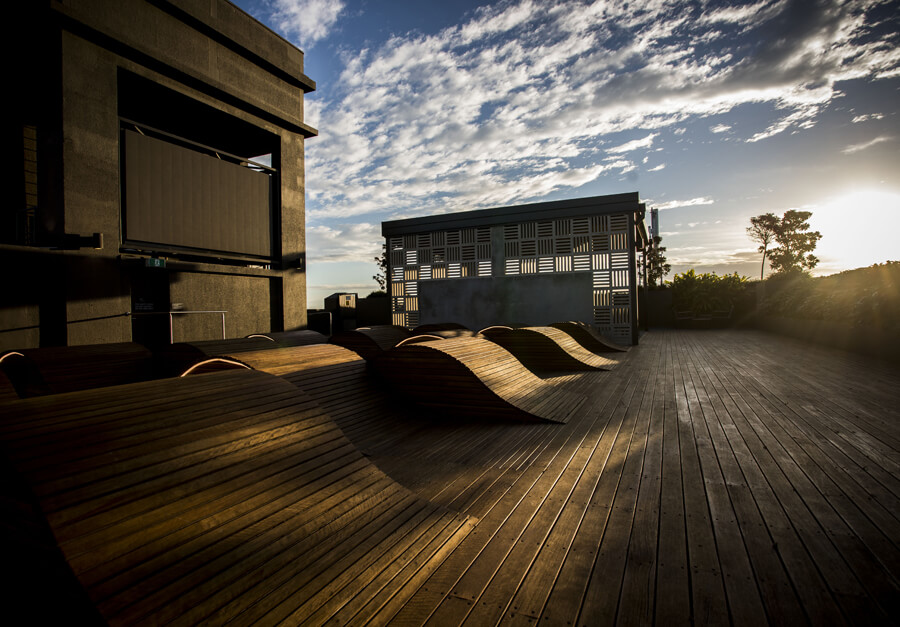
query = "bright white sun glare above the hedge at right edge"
xmin=809 ymin=190 xmax=900 ymax=274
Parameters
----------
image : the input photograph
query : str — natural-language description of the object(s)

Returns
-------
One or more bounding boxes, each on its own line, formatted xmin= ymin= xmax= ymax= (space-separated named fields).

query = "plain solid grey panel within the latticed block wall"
xmin=419 ymin=273 xmax=593 ymax=331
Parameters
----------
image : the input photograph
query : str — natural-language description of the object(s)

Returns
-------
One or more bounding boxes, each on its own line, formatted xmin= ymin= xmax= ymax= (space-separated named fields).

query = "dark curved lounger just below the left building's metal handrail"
xmin=157 ymin=331 xmax=327 ymax=376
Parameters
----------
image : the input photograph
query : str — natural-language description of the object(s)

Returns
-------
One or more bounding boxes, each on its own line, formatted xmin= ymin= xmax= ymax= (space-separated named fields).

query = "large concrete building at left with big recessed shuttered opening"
xmin=0 ymin=0 xmax=316 ymax=348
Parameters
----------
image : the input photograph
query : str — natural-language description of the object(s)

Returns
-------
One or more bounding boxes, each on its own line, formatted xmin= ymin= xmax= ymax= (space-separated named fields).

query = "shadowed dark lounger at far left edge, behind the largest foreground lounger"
xmin=0 ymin=342 xmax=153 ymax=398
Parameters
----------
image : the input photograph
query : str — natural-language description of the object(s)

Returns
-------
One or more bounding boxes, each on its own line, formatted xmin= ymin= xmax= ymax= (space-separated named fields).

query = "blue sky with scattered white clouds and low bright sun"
xmin=229 ymin=0 xmax=900 ymax=308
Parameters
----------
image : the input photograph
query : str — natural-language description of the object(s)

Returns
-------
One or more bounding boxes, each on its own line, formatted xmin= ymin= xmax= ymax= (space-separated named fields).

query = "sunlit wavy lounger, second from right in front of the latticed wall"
xmin=482 ymin=327 xmax=616 ymax=372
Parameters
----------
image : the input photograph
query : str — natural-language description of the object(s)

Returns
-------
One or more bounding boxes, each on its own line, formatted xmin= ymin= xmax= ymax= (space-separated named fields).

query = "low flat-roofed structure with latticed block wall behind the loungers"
xmin=382 ymin=192 xmax=647 ymax=344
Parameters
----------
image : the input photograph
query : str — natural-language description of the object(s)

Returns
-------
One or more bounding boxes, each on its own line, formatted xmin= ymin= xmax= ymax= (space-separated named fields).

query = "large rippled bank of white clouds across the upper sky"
xmin=304 ymin=0 xmax=900 ymax=222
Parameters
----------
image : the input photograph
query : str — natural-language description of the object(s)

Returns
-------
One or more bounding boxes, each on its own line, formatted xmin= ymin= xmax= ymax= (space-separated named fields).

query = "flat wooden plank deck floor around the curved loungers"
xmin=3 ymin=331 xmax=900 ymax=626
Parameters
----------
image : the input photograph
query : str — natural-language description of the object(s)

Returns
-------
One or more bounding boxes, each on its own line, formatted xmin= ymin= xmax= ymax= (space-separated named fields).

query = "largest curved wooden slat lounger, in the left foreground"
xmin=0 ymin=370 xmax=472 ymax=625
